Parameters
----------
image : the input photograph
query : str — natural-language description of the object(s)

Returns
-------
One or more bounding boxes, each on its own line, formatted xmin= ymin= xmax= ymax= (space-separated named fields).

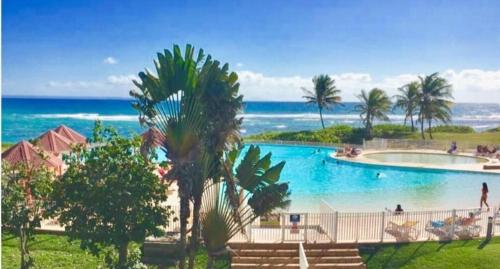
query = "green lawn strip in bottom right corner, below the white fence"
xmin=361 ymin=237 xmax=500 ymax=269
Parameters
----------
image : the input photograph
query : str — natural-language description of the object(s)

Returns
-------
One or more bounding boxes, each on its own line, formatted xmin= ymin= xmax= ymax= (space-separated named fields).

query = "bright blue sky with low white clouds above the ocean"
xmin=2 ymin=0 xmax=500 ymax=103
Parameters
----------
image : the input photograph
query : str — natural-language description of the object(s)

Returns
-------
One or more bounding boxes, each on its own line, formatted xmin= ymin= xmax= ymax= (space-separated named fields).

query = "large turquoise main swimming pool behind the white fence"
xmin=156 ymin=144 xmax=500 ymax=212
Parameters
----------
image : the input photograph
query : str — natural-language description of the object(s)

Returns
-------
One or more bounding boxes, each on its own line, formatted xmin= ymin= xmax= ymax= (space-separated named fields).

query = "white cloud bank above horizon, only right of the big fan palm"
xmin=238 ymin=69 xmax=500 ymax=103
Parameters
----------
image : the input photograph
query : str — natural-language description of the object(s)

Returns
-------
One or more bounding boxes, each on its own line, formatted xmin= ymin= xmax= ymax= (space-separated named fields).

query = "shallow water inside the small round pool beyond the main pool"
xmin=363 ymin=152 xmax=486 ymax=165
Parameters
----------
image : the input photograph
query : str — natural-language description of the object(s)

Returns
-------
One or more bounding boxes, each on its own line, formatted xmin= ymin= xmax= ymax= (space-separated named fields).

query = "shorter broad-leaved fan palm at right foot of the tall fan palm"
xmin=202 ymin=145 xmax=290 ymax=268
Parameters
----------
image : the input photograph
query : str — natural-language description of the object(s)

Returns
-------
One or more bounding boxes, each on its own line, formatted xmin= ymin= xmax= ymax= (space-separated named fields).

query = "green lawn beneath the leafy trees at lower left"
xmin=2 ymin=231 xmax=104 ymax=269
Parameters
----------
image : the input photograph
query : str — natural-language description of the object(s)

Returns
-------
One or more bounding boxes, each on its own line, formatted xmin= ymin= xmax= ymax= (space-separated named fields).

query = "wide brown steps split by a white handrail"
xmin=230 ymin=243 xmax=366 ymax=269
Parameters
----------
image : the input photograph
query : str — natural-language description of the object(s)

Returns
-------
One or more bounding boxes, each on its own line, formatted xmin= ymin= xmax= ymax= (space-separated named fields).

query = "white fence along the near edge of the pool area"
xmin=231 ymin=205 xmax=500 ymax=243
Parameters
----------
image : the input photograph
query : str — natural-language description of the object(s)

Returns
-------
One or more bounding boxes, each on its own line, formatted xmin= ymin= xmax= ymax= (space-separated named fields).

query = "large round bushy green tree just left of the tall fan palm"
xmin=49 ymin=122 xmax=171 ymax=268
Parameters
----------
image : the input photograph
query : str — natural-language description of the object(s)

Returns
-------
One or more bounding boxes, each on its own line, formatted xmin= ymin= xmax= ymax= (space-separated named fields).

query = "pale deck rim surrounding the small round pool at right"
xmin=330 ymin=150 xmax=500 ymax=174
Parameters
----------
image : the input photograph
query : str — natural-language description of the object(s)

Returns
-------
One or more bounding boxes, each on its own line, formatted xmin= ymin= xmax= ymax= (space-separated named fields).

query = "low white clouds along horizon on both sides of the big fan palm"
xmin=41 ymin=69 xmax=500 ymax=103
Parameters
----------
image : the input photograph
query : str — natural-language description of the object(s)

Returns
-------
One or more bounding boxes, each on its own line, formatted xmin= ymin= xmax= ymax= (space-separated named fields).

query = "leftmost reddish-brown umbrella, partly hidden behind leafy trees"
xmin=2 ymin=140 xmax=63 ymax=173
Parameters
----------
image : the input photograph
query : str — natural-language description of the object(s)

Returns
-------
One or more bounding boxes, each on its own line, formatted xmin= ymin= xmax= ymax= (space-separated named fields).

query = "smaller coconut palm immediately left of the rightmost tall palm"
xmin=394 ymin=81 xmax=420 ymax=132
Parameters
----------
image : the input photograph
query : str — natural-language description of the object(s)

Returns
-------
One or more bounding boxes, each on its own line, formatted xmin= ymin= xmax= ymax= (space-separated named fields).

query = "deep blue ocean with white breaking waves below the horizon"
xmin=2 ymin=97 xmax=500 ymax=142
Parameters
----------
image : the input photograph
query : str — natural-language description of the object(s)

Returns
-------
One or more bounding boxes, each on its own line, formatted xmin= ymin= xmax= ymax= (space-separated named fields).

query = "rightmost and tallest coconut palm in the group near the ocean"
xmin=419 ymin=73 xmax=453 ymax=139
